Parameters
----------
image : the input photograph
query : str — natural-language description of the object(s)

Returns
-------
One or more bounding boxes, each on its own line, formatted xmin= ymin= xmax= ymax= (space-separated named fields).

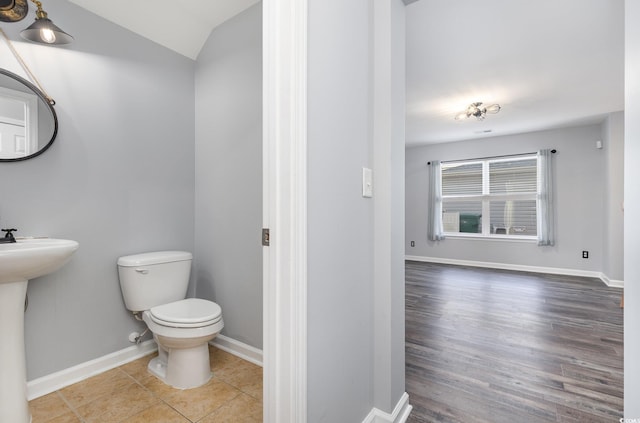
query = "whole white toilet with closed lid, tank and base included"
xmin=118 ymin=251 xmax=224 ymax=389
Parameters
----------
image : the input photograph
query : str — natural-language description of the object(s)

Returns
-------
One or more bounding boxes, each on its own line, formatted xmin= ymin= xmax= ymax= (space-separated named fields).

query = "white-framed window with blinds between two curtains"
xmin=440 ymin=154 xmax=538 ymax=239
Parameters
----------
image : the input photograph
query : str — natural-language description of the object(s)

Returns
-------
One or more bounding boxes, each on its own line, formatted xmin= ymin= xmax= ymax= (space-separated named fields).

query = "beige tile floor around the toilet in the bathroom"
xmin=29 ymin=347 xmax=262 ymax=423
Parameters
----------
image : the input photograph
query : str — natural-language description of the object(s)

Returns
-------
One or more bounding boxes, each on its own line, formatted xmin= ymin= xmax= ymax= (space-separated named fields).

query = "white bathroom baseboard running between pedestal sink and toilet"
xmin=27 ymin=339 xmax=158 ymax=401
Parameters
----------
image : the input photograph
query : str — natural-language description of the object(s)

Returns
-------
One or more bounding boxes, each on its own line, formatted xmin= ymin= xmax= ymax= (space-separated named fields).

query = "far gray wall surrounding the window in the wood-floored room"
xmin=405 ymin=119 xmax=622 ymax=276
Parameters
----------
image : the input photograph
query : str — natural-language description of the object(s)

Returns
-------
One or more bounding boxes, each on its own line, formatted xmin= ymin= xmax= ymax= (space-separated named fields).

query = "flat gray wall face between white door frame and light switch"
xmin=307 ymin=0 xmax=374 ymax=422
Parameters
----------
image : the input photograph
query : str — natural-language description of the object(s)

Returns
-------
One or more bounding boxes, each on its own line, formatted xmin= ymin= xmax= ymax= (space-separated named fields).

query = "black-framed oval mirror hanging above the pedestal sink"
xmin=0 ymin=68 xmax=58 ymax=162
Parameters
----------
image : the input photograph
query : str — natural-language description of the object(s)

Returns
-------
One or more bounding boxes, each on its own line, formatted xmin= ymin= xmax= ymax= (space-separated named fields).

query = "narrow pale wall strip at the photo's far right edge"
xmin=624 ymin=0 xmax=640 ymax=419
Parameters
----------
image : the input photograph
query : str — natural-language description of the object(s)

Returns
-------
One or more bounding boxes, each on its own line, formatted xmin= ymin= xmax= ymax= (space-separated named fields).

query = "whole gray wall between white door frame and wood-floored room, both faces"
xmin=307 ymin=0 xmax=404 ymax=422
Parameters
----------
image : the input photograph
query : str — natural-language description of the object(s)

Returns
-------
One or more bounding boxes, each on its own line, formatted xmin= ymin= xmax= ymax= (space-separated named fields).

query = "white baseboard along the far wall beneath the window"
xmin=405 ymin=256 xmax=624 ymax=288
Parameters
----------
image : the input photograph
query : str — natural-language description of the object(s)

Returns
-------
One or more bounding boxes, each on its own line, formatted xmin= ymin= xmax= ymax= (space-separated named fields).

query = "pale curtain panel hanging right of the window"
xmin=537 ymin=150 xmax=555 ymax=246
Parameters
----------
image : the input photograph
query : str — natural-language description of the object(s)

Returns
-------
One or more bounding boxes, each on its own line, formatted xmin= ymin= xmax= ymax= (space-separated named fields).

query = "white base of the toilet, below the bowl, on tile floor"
xmin=147 ymin=342 xmax=211 ymax=389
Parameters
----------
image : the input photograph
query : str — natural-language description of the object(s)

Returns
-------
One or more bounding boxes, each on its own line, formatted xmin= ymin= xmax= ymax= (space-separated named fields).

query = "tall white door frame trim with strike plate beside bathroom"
xmin=262 ymin=0 xmax=307 ymax=423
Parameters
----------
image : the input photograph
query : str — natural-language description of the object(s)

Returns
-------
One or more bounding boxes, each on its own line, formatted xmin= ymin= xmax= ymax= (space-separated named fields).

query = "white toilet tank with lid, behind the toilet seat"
xmin=118 ymin=251 xmax=193 ymax=311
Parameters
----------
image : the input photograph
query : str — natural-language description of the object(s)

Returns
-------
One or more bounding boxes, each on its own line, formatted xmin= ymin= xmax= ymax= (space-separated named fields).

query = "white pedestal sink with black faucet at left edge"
xmin=0 ymin=238 xmax=78 ymax=423
